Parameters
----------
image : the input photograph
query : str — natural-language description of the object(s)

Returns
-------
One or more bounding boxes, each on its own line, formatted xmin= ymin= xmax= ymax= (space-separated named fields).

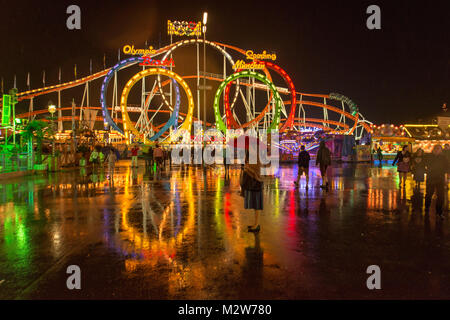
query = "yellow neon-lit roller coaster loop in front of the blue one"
xmin=120 ymin=68 xmax=194 ymax=139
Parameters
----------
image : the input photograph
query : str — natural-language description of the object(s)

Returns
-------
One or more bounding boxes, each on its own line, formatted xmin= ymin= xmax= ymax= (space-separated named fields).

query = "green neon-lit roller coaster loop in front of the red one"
xmin=214 ymin=70 xmax=283 ymax=133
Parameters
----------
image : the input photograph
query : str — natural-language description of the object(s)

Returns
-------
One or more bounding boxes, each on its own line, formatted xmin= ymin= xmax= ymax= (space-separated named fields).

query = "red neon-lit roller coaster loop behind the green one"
xmin=224 ymin=60 xmax=297 ymax=132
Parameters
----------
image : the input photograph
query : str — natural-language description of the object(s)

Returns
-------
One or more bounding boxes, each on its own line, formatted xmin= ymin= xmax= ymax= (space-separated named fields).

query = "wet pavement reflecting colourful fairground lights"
xmin=0 ymin=161 xmax=450 ymax=299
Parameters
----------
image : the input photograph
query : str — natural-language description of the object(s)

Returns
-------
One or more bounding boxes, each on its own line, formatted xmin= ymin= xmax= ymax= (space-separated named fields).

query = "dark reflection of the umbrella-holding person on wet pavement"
xmin=241 ymin=232 xmax=264 ymax=298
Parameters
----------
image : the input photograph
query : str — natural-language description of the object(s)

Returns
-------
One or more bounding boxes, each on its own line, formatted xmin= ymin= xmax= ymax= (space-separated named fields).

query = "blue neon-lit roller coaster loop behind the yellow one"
xmin=100 ymin=57 xmax=180 ymax=141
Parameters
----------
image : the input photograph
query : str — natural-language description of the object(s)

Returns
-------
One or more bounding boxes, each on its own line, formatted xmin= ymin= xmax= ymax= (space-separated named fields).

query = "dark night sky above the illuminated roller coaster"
xmin=0 ymin=0 xmax=450 ymax=123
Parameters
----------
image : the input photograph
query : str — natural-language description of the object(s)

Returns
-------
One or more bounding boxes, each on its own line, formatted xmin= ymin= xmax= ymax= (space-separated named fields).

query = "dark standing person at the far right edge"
xmin=425 ymin=145 xmax=448 ymax=218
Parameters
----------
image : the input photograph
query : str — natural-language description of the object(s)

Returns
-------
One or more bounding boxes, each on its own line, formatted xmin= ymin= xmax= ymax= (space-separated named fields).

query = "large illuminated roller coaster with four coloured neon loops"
xmin=0 ymin=38 xmax=371 ymax=143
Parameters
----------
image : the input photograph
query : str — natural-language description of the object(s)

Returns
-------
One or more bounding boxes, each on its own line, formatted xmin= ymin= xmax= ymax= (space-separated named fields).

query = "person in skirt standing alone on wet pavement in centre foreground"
xmin=241 ymin=153 xmax=263 ymax=232
